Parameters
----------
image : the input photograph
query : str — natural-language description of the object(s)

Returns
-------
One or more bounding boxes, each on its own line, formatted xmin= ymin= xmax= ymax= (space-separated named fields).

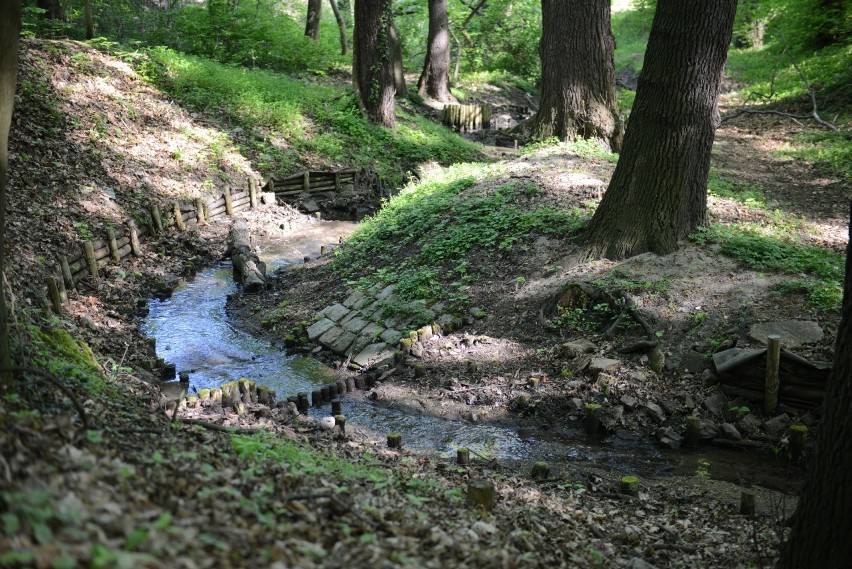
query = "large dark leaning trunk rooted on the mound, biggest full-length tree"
xmin=586 ymin=0 xmax=737 ymax=259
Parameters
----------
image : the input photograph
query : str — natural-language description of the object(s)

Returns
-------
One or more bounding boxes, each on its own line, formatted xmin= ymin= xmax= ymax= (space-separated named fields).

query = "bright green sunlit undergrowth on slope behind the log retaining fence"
xmin=141 ymin=48 xmax=481 ymax=187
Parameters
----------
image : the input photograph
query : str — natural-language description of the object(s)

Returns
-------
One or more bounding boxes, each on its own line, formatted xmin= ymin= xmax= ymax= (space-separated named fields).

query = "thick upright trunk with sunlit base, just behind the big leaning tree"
xmin=524 ymin=0 xmax=622 ymax=152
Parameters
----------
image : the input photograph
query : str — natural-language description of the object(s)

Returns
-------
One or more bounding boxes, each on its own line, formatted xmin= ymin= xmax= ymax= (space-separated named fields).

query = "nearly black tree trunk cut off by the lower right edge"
xmin=777 ymin=199 xmax=852 ymax=569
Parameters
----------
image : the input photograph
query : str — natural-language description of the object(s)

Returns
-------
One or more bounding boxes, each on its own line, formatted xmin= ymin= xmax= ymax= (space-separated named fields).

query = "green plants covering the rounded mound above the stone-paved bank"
xmin=332 ymin=164 xmax=585 ymax=324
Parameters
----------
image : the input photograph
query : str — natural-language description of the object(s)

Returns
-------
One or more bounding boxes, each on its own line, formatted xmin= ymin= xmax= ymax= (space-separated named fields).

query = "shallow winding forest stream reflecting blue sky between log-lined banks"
xmin=142 ymin=222 xmax=801 ymax=493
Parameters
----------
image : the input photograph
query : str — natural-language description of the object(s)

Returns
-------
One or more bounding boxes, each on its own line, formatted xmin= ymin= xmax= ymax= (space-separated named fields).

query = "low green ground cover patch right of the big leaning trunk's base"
xmin=690 ymin=224 xmax=845 ymax=311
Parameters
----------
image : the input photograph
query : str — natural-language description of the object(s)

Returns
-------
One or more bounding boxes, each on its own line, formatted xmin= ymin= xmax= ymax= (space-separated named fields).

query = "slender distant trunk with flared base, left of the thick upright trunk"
xmin=417 ymin=0 xmax=457 ymax=103
